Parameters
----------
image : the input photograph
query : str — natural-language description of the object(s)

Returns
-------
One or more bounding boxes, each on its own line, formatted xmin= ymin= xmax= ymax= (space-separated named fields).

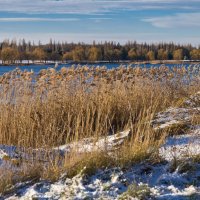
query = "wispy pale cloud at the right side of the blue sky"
xmin=142 ymin=13 xmax=200 ymax=28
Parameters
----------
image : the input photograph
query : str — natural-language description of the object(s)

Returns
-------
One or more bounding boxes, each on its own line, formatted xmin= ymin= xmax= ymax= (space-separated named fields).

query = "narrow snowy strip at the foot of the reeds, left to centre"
xmin=0 ymin=130 xmax=130 ymax=168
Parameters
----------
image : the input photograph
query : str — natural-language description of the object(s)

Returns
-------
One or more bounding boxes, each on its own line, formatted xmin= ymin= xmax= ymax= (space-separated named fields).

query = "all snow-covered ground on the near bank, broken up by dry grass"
xmin=0 ymin=93 xmax=200 ymax=200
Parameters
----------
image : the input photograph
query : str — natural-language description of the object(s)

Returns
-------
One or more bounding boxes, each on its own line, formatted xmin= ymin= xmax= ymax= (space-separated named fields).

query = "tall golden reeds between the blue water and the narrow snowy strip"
xmin=0 ymin=65 xmax=197 ymax=148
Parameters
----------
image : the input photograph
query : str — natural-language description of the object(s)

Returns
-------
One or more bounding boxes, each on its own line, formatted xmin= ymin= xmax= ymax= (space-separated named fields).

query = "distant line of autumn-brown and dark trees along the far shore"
xmin=0 ymin=39 xmax=200 ymax=64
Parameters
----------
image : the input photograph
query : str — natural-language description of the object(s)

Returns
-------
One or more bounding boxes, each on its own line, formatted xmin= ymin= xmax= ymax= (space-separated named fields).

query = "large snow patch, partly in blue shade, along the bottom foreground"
xmin=4 ymin=163 xmax=200 ymax=200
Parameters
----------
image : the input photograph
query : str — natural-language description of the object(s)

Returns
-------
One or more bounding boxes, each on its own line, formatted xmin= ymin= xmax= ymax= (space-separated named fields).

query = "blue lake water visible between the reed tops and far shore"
xmin=0 ymin=63 xmax=197 ymax=75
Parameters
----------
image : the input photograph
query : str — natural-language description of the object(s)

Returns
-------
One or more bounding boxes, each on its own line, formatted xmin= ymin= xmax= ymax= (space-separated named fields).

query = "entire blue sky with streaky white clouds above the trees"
xmin=0 ymin=0 xmax=200 ymax=45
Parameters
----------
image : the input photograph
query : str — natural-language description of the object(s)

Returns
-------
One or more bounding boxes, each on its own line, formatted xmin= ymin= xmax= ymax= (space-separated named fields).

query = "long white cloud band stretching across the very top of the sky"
xmin=0 ymin=0 xmax=200 ymax=14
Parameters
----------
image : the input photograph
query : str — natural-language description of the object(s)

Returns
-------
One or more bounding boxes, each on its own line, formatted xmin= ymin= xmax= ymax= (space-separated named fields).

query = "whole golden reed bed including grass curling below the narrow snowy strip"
xmin=0 ymin=66 xmax=200 ymax=195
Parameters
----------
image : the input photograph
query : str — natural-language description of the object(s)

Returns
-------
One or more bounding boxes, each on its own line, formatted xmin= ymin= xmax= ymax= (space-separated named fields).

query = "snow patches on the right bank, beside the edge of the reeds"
xmin=152 ymin=92 xmax=200 ymax=161
